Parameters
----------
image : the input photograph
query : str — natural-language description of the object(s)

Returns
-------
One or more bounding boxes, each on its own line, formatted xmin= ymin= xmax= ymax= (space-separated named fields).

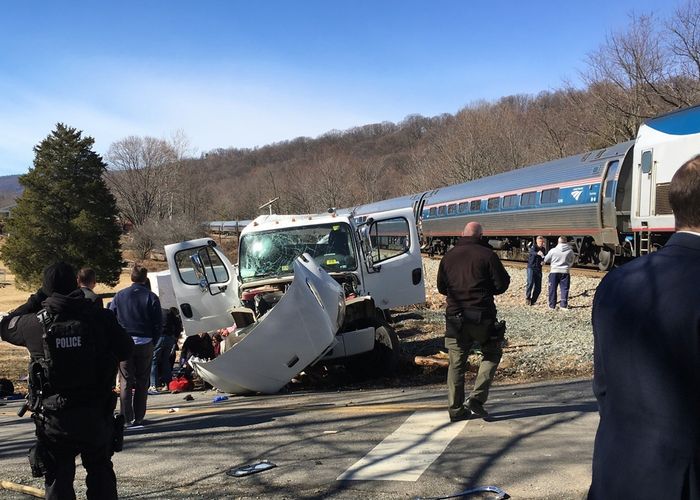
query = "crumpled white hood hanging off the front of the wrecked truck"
xmin=192 ymin=255 xmax=345 ymax=394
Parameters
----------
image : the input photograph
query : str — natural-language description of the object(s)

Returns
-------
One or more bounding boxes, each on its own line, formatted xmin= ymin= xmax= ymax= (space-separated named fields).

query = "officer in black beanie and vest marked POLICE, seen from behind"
xmin=0 ymin=262 xmax=133 ymax=499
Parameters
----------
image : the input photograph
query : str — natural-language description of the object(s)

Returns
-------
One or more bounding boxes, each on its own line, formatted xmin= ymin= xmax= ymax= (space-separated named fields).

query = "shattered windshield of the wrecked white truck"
xmin=238 ymin=223 xmax=357 ymax=283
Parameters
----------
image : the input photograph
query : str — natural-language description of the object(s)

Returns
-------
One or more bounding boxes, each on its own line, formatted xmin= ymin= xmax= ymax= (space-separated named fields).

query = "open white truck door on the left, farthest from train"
xmin=165 ymin=238 xmax=239 ymax=335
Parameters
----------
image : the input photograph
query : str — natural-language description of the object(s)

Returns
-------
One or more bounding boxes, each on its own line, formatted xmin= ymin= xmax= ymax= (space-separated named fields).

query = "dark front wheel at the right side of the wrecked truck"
xmin=348 ymin=322 xmax=401 ymax=378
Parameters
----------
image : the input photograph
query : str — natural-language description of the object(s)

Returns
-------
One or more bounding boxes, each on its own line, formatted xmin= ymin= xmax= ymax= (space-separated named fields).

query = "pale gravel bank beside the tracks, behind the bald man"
xmin=397 ymin=258 xmax=600 ymax=380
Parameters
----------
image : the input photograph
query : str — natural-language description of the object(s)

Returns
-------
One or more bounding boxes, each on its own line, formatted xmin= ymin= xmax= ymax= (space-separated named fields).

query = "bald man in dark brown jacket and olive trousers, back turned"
xmin=437 ymin=222 xmax=510 ymax=421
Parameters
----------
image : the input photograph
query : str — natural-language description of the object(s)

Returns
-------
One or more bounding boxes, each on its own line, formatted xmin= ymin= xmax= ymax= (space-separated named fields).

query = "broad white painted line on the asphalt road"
xmin=338 ymin=410 xmax=467 ymax=481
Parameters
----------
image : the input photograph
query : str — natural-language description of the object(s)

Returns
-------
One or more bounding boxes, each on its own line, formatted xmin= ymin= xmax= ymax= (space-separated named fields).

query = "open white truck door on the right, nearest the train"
xmin=358 ymin=207 xmax=425 ymax=309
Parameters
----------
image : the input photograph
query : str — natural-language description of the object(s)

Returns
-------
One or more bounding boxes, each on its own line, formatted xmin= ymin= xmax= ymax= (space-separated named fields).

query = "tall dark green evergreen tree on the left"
xmin=0 ymin=123 xmax=122 ymax=288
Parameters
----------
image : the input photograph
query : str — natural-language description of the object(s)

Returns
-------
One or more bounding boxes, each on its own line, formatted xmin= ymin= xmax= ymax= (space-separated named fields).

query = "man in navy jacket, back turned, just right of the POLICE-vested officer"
xmin=109 ymin=265 xmax=162 ymax=425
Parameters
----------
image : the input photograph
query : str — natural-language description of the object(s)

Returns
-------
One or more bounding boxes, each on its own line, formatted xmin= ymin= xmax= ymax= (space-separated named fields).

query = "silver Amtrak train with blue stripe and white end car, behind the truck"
xmin=347 ymin=106 xmax=700 ymax=270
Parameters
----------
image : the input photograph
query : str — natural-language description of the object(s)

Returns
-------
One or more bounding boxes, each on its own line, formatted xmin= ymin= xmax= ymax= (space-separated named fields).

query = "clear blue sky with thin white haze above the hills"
xmin=0 ymin=0 xmax=679 ymax=175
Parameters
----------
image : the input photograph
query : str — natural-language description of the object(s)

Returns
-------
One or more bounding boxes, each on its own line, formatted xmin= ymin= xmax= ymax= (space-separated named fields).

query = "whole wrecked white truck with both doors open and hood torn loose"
xmin=165 ymin=209 xmax=425 ymax=393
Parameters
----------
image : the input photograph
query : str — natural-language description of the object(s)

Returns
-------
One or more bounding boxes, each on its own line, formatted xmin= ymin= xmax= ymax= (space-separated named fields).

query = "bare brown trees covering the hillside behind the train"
xmin=0 ymin=0 xmax=700 ymax=288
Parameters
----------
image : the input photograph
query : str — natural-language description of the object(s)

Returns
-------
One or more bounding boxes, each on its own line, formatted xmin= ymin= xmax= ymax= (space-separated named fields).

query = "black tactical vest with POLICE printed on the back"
xmin=29 ymin=309 xmax=99 ymax=412
